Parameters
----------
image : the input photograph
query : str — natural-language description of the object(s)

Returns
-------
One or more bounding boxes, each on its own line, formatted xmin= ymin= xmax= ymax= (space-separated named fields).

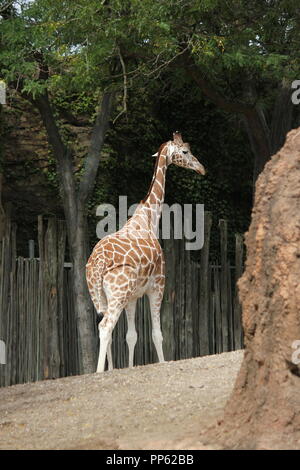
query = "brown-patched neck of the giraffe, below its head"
xmin=142 ymin=146 xmax=168 ymax=237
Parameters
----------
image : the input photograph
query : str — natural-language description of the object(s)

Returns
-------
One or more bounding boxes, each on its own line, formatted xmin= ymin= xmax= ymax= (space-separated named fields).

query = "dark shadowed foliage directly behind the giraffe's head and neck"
xmin=85 ymin=75 xmax=253 ymax=259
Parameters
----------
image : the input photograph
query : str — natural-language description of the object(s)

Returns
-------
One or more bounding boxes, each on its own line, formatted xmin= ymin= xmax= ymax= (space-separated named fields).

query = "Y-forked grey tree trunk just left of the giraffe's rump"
xmin=32 ymin=92 xmax=114 ymax=373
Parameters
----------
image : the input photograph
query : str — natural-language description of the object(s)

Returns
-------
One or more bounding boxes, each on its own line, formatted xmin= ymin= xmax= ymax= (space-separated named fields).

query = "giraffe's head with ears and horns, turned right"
xmin=153 ymin=132 xmax=205 ymax=175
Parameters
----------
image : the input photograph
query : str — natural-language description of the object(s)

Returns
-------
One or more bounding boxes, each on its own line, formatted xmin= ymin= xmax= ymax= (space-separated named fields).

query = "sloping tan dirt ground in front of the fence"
xmin=0 ymin=351 xmax=243 ymax=450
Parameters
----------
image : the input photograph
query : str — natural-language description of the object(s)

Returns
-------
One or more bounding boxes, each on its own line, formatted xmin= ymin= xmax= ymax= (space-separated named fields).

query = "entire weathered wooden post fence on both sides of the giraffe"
xmin=0 ymin=213 xmax=243 ymax=386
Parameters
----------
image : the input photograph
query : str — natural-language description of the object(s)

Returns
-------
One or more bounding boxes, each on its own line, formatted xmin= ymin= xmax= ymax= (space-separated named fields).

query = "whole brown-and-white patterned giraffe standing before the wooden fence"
xmin=86 ymin=132 xmax=205 ymax=372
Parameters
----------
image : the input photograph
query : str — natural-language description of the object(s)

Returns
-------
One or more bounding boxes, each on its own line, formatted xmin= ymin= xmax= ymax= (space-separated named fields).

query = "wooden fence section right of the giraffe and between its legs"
xmin=113 ymin=213 xmax=244 ymax=368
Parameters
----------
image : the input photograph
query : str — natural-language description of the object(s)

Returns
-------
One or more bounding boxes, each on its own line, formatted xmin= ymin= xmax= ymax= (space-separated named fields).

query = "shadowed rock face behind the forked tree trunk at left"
xmin=0 ymin=96 xmax=91 ymax=256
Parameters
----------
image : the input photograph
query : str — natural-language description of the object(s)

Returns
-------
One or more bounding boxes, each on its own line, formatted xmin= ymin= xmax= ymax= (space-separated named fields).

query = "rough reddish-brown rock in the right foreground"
xmin=219 ymin=128 xmax=300 ymax=449
